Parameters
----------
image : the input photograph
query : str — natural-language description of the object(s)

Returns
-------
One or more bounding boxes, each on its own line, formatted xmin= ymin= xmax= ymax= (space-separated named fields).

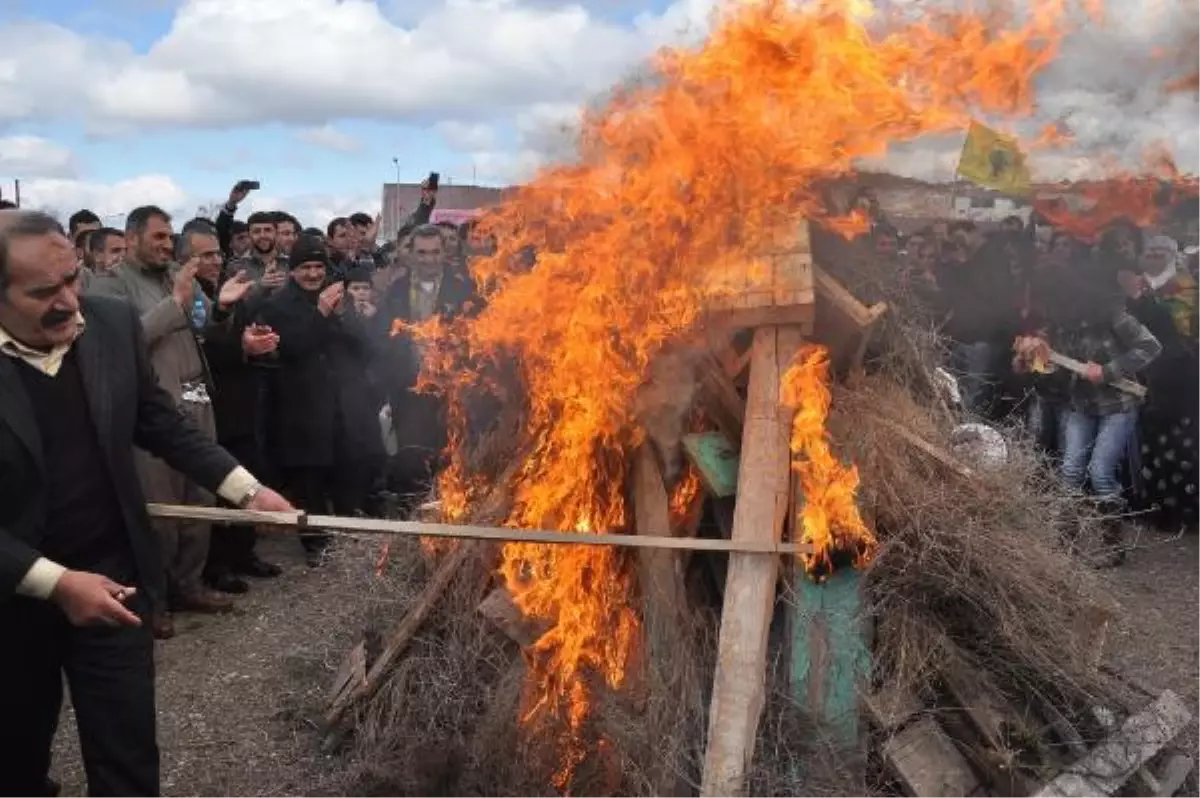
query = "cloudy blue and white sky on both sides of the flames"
xmin=0 ymin=0 xmax=1200 ymax=223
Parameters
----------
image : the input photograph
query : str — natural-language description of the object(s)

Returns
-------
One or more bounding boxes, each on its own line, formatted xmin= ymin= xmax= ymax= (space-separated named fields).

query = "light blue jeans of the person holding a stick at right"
xmin=1058 ymin=408 xmax=1138 ymax=499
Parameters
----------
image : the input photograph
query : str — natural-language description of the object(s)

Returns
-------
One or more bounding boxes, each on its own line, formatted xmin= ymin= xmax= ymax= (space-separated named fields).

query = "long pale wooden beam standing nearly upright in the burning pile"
xmin=701 ymin=328 xmax=803 ymax=798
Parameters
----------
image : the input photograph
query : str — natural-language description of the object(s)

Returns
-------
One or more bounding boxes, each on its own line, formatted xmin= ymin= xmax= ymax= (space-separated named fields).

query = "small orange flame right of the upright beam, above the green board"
xmin=782 ymin=346 xmax=878 ymax=580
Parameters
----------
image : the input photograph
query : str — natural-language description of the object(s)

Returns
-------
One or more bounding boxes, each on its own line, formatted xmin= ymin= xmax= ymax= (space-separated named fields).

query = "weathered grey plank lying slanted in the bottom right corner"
xmin=1034 ymin=690 xmax=1192 ymax=798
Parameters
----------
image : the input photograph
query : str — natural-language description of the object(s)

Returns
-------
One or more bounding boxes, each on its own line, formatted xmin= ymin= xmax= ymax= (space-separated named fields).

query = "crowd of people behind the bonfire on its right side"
xmin=871 ymin=195 xmax=1200 ymax=564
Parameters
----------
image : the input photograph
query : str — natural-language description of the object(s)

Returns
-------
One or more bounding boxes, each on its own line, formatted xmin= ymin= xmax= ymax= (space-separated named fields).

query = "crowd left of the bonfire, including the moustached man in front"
xmin=0 ymin=178 xmax=484 ymax=798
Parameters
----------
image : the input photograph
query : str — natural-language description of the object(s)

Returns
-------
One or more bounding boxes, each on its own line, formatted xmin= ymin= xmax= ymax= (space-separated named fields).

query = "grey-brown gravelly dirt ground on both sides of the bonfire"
xmin=55 ymin=525 xmax=1200 ymax=798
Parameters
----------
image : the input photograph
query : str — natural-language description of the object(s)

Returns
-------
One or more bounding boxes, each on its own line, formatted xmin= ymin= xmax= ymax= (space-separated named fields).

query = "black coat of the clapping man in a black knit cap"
xmin=258 ymin=281 xmax=384 ymax=468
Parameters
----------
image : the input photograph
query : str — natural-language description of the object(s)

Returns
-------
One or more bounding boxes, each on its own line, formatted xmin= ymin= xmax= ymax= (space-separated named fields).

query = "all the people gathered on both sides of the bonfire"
xmin=0 ymin=176 xmax=1200 ymax=797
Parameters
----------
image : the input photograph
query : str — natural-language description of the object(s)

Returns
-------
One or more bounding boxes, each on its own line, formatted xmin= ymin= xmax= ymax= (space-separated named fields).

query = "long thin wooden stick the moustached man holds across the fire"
xmin=146 ymin=503 xmax=812 ymax=556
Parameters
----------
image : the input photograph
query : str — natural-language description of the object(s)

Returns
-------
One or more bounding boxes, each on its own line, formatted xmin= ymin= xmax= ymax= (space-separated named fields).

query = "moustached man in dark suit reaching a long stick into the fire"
xmin=0 ymin=211 xmax=292 ymax=798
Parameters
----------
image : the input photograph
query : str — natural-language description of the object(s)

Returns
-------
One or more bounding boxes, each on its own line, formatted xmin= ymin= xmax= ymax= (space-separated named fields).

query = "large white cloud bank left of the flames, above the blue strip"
xmin=0 ymin=0 xmax=712 ymax=131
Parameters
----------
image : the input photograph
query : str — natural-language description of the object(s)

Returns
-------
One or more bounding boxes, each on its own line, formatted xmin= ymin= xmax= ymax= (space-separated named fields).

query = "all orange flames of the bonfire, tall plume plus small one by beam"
xmin=415 ymin=0 xmax=1099 ymax=786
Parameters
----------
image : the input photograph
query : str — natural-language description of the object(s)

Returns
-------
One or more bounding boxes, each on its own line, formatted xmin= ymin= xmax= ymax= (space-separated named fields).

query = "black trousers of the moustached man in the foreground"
xmin=0 ymin=594 xmax=158 ymax=798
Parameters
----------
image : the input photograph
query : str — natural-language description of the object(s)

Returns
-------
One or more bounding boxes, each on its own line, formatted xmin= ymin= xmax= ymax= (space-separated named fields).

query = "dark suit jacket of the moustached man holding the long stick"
xmin=0 ymin=296 xmax=238 ymax=601
